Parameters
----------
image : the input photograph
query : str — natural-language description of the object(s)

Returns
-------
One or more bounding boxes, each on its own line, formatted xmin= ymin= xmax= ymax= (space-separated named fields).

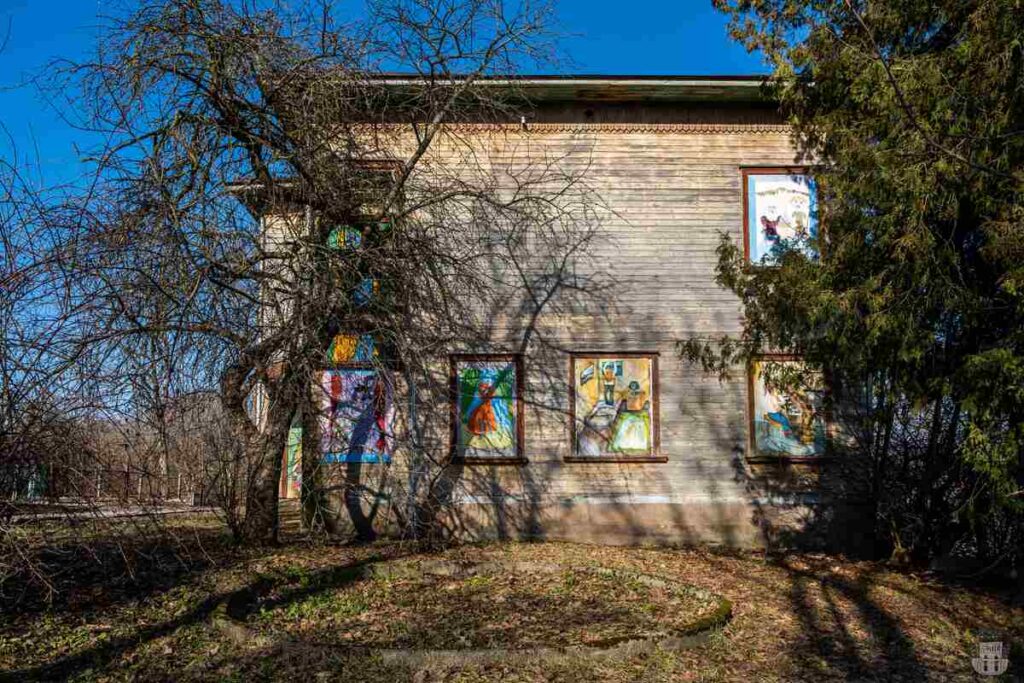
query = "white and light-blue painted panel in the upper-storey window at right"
xmin=744 ymin=173 xmax=818 ymax=263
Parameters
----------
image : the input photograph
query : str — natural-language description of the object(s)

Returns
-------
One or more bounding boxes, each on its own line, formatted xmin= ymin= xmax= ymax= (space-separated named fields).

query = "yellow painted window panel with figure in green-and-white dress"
xmin=572 ymin=355 xmax=657 ymax=458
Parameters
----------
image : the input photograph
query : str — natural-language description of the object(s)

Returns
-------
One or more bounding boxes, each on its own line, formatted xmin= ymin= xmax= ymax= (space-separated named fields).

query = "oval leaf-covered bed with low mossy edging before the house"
xmin=253 ymin=560 xmax=731 ymax=651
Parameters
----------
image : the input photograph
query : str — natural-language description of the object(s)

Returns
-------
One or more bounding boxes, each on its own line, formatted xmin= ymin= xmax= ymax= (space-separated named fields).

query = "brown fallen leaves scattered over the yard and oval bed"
xmin=0 ymin=543 xmax=1024 ymax=682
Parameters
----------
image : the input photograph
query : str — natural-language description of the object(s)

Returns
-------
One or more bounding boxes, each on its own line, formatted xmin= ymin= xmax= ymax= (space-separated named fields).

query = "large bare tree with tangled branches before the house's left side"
xmin=8 ymin=0 xmax=599 ymax=543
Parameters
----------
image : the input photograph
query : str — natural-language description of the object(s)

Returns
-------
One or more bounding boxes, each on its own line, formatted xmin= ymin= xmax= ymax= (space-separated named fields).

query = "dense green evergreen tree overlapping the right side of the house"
xmin=683 ymin=0 xmax=1024 ymax=571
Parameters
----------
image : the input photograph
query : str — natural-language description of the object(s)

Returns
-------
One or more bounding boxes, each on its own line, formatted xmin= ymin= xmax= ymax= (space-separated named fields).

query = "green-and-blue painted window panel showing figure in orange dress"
xmin=452 ymin=356 xmax=522 ymax=460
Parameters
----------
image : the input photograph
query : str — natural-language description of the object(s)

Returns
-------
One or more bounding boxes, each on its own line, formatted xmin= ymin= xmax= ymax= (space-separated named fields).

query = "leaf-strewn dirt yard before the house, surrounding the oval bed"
xmin=0 ymin=520 xmax=1024 ymax=683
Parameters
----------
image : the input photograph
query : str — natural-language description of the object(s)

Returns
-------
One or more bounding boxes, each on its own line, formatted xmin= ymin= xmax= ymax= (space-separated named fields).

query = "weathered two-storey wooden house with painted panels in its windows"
xmin=253 ymin=77 xmax=857 ymax=547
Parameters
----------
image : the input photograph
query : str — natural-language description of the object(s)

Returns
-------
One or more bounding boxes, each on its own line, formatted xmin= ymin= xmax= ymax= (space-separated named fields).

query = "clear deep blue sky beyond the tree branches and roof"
xmin=0 ymin=0 xmax=766 ymax=182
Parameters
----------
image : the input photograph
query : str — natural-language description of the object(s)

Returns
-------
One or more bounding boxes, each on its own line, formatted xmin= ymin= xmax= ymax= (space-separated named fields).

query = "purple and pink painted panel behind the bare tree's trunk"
xmin=322 ymin=369 xmax=395 ymax=463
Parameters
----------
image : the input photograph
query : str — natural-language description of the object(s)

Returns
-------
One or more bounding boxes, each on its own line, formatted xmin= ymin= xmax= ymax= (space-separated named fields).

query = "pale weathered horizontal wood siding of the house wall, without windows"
xmin=274 ymin=116 xmax=823 ymax=545
